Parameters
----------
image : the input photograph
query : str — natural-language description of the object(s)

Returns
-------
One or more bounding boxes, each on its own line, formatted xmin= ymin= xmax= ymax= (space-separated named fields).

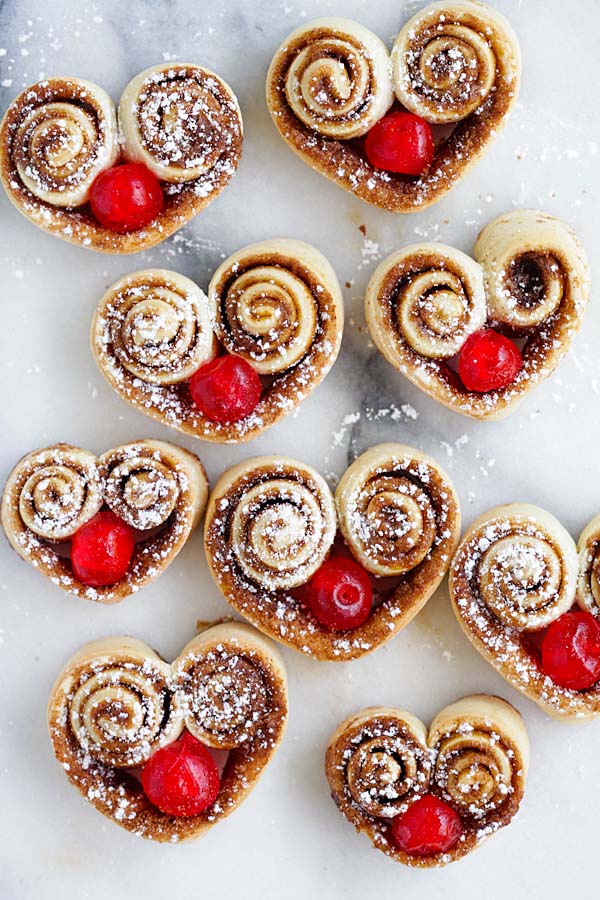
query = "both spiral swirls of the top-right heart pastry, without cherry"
xmin=276 ymin=2 xmax=519 ymax=140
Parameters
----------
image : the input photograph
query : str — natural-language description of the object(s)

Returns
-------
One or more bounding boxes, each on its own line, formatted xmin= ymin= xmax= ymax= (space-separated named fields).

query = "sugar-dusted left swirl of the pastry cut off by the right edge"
xmin=451 ymin=504 xmax=577 ymax=631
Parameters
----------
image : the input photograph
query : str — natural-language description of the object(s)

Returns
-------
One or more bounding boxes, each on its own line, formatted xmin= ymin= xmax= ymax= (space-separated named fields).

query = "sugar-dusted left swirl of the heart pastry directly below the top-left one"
xmin=91 ymin=269 xmax=216 ymax=385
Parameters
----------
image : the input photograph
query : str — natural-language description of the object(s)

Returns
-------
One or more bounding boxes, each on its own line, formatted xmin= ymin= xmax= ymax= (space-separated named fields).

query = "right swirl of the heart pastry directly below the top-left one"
xmin=209 ymin=240 xmax=328 ymax=375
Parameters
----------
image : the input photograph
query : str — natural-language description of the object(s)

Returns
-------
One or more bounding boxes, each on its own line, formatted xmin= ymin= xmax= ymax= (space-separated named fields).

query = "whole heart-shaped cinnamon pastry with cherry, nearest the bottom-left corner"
xmin=48 ymin=622 xmax=288 ymax=843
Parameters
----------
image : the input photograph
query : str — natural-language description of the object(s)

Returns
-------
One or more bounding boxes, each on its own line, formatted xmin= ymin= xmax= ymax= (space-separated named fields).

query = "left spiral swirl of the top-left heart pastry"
xmin=11 ymin=78 xmax=118 ymax=207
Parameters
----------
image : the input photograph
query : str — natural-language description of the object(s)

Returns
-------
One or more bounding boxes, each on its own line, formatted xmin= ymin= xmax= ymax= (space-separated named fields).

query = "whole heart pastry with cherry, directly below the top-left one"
xmin=91 ymin=238 xmax=344 ymax=443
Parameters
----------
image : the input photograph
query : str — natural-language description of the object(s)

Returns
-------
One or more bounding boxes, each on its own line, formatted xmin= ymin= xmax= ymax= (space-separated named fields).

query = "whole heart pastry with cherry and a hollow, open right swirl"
xmin=366 ymin=209 xmax=590 ymax=419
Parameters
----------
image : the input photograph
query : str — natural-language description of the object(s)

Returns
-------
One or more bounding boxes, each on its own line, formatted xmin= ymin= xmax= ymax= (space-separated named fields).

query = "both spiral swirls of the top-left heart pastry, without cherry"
xmin=8 ymin=64 xmax=242 ymax=208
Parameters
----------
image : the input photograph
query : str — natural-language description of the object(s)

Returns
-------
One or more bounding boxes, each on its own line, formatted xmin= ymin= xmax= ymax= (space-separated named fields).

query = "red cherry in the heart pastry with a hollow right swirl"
xmin=458 ymin=328 xmax=523 ymax=394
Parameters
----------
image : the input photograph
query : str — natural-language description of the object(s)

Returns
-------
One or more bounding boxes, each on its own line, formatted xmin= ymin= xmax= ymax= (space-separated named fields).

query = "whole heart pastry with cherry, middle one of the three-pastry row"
xmin=204 ymin=444 xmax=460 ymax=661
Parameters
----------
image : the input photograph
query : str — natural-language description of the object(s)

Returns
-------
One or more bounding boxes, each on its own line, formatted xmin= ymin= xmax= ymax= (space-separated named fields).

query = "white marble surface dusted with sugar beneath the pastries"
xmin=0 ymin=0 xmax=600 ymax=900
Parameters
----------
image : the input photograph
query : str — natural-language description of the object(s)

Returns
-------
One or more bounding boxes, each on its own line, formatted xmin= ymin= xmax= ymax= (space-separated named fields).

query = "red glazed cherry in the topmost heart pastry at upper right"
xmin=365 ymin=111 xmax=435 ymax=175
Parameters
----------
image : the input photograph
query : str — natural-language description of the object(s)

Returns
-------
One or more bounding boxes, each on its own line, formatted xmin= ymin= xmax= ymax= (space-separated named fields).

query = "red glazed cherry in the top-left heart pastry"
xmin=90 ymin=163 xmax=164 ymax=234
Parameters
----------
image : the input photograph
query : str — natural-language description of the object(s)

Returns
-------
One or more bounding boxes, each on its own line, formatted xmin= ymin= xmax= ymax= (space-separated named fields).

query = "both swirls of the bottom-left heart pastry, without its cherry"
xmin=50 ymin=624 xmax=286 ymax=768
